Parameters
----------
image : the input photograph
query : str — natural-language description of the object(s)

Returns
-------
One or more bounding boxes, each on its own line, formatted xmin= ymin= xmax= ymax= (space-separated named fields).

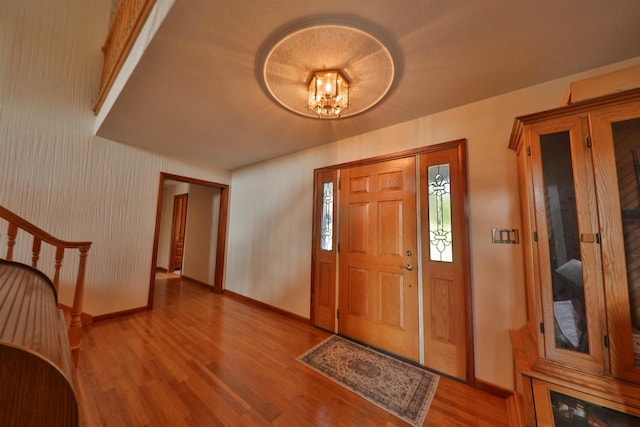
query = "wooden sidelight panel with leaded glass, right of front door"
xmin=420 ymin=147 xmax=471 ymax=379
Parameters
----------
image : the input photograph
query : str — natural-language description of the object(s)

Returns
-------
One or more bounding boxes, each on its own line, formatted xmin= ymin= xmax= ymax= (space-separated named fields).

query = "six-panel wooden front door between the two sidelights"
xmin=338 ymin=157 xmax=419 ymax=360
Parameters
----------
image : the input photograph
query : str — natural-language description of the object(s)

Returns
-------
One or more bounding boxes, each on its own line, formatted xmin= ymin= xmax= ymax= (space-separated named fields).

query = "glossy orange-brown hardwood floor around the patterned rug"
xmin=77 ymin=279 xmax=508 ymax=427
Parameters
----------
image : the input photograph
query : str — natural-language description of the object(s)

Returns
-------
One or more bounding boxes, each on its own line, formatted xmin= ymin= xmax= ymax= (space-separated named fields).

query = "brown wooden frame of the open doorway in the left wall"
xmin=147 ymin=172 xmax=229 ymax=310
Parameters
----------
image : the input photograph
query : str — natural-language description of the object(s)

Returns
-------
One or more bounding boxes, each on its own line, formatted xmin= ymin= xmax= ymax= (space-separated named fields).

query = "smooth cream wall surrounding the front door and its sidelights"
xmin=226 ymin=58 xmax=640 ymax=388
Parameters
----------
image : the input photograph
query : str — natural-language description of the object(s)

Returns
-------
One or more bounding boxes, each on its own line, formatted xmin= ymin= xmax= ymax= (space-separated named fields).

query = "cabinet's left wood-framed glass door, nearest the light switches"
xmin=528 ymin=116 xmax=605 ymax=372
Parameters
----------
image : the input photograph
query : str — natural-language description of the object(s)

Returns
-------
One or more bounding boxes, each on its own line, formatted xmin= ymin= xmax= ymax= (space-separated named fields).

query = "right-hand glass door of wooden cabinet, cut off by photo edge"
xmin=590 ymin=102 xmax=640 ymax=381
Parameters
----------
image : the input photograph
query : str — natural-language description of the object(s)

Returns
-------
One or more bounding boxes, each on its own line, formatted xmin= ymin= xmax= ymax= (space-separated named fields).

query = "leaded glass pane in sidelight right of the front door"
xmin=427 ymin=164 xmax=453 ymax=262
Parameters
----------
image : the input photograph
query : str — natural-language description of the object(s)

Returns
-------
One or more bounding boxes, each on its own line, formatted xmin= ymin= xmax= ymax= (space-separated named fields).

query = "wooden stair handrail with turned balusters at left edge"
xmin=0 ymin=205 xmax=91 ymax=366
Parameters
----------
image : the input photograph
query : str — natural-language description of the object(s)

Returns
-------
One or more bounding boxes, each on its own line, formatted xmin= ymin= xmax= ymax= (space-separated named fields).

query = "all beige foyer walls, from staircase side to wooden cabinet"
xmin=0 ymin=0 xmax=640 ymax=394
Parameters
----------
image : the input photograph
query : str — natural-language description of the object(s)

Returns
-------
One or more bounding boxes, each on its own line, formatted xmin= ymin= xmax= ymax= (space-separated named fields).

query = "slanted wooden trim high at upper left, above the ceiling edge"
xmin=93 ymin=0 xmax=156 ymax=114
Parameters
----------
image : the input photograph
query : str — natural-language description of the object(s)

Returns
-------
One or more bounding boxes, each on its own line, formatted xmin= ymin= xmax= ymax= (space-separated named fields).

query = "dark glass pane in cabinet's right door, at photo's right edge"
xmin=612 ymin=119 xmax=640 ymax=366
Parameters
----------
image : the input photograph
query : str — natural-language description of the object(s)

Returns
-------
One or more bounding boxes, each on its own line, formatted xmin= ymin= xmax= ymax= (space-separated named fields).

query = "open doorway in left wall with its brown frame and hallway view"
xmin=147 ymin=172 xmax=229 ymax=309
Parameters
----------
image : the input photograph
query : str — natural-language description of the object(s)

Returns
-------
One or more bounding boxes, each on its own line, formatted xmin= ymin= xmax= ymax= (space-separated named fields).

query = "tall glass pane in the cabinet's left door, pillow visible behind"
xmin=540 ymin=131 xmax=589 ymax=353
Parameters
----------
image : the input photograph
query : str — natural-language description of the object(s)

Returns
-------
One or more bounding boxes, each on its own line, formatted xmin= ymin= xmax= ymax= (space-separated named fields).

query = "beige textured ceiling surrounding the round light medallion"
xmin=98 ymin=0 xmax=640 ymax=169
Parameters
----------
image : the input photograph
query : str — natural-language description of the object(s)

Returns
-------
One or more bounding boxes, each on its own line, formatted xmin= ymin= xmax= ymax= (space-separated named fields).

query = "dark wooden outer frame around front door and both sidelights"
xmin=310 ymin=139 xmax=476 ymax=385
